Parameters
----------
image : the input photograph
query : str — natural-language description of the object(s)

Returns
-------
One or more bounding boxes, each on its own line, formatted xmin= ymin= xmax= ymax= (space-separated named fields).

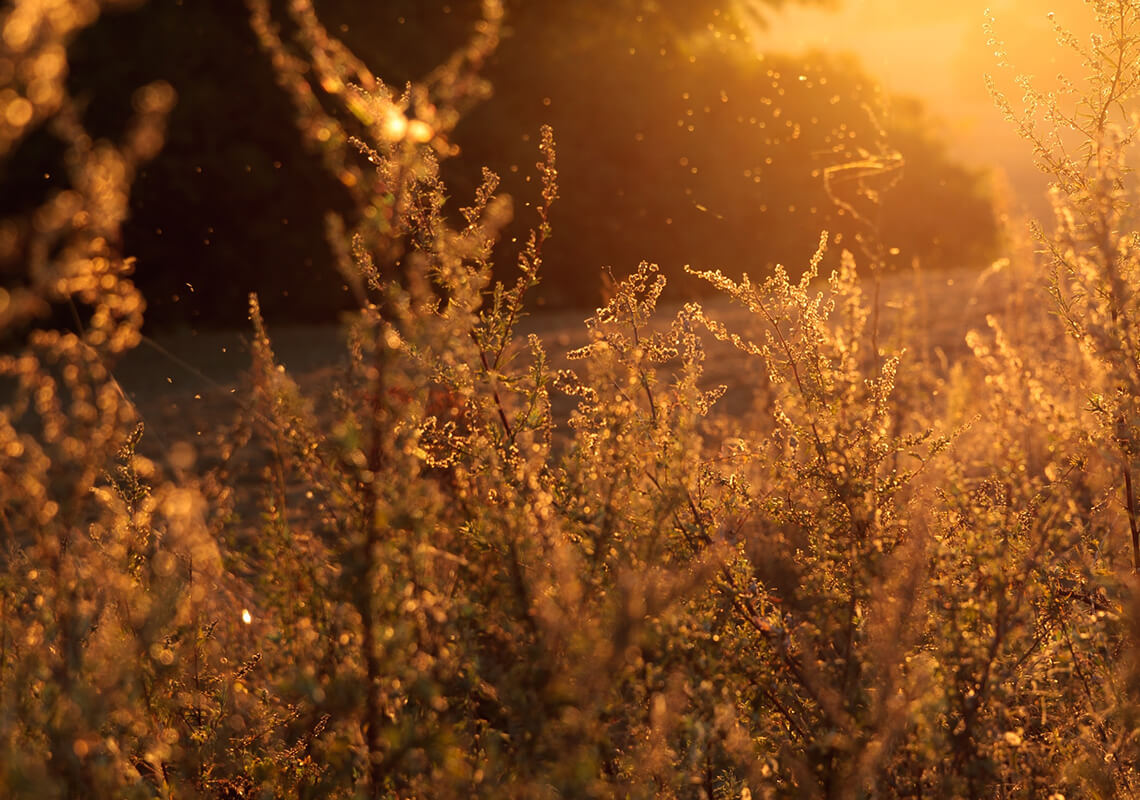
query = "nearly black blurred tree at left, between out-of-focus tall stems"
xmin=64 ymin=0 xmax=349 ymax=327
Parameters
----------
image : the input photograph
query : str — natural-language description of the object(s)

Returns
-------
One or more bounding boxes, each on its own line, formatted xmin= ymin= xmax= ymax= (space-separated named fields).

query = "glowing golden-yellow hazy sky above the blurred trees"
xmin=757 ymin=0 xmax=1089 ymax=210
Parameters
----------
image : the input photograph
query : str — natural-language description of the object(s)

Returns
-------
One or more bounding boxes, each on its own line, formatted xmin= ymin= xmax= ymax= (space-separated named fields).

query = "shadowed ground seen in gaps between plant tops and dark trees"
xmin=114 ymin=270 xmax=1044 ymax=474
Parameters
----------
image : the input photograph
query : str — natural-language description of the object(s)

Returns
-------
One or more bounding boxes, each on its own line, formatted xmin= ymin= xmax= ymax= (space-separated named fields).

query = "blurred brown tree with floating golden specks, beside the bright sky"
xmin=428 ymin=3 xmax=996 ymax=303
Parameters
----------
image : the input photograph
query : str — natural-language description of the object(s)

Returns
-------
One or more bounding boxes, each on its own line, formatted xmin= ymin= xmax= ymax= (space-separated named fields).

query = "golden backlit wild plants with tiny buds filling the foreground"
xmin=0 ymin=0 xmax=1140 ymax=798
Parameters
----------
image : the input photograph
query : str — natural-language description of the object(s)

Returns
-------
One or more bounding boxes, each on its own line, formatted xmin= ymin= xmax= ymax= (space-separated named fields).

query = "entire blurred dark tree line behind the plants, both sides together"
xmin=8 ymin=0 xmax=995 ymax=325
